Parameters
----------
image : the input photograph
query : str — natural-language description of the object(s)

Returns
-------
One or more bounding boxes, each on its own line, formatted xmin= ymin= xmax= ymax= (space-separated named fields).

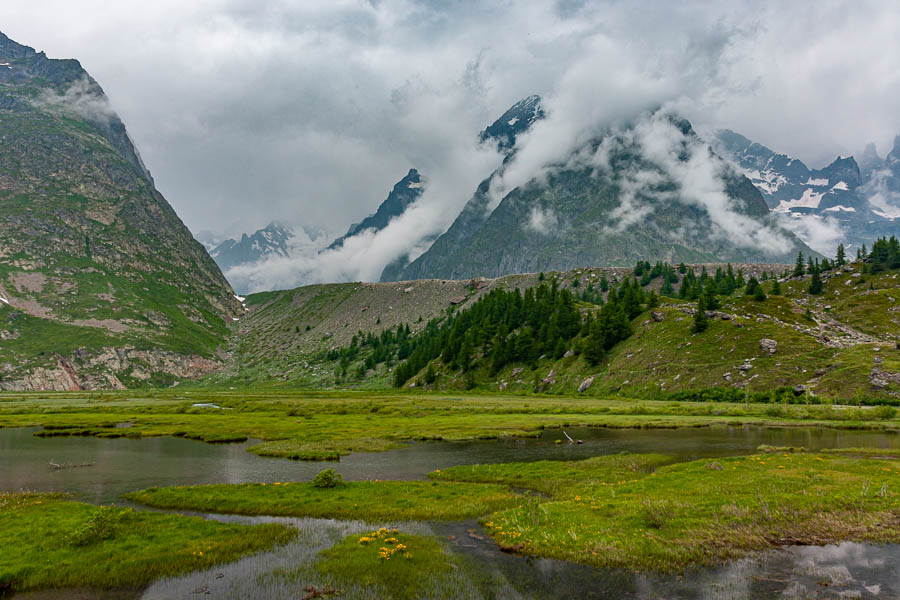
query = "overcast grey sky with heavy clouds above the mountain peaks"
xmin=0 ymin=0 xmax=900 ymax=239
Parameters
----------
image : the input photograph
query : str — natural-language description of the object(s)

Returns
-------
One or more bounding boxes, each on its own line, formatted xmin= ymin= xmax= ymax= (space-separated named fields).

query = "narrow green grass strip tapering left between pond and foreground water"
xmin=126 ymin=481 xmax=521 ymax=522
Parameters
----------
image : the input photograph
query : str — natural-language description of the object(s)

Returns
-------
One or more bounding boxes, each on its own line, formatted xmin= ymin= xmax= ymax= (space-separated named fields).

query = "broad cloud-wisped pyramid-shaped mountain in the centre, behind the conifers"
xmin=390 ymin=113 xmax=810 ymax=280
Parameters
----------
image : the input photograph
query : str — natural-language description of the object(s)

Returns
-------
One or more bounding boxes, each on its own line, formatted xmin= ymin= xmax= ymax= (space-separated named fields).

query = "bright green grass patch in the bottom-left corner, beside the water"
xmin=0 ymin=492 xmax=296 ymax=592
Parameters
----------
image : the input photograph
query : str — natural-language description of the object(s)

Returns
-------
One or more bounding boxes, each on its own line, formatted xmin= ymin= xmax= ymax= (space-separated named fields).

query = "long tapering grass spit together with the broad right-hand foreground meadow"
xmin=129 ymin=451 xmax=900 ymax=572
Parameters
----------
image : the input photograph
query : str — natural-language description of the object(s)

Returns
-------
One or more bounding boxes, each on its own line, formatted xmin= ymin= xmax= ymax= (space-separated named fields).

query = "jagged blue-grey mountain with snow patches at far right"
xmin=715 ymin=129 xmax=900 ymax=251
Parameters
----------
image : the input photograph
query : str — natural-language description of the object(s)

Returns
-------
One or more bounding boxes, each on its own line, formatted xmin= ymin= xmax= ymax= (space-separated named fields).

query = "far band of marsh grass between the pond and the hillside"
xmin=0 ymin=390 xmax=900 ymax=460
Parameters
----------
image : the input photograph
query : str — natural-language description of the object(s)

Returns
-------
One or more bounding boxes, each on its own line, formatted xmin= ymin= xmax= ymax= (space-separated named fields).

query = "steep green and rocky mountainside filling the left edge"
xmin=0 ymin=34 xmax=243 ymax=389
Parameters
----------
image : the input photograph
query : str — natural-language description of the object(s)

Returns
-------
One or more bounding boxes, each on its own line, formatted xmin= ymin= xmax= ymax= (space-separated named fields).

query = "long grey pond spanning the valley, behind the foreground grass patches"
xmin=0 ymin=426 xmax=900 ymax=504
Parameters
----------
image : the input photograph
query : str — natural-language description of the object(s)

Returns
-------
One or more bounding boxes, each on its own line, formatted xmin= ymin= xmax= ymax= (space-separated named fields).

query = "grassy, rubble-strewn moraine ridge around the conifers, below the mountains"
xmin=220 ymin=255 xmax=900 ymax=401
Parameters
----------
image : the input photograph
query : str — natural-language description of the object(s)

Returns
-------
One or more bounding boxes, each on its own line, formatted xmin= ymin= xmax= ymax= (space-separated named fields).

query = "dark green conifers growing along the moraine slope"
xmin=324 ymin=237 xmax=900 ymax=387
